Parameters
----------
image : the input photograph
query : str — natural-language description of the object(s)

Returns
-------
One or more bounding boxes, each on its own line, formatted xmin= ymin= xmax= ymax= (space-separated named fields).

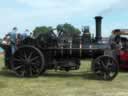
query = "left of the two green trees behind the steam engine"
xmin=33 ymin=26 xmax=52 ymax=38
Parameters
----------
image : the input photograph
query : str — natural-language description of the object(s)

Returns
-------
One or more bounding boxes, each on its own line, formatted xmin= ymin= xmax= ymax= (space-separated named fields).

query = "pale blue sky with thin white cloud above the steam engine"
xmin=0 ymin=0 xmax=128 ymax=37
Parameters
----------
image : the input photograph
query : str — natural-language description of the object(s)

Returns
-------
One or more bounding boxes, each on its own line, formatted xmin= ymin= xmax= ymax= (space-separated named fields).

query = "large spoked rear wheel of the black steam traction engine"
xmin=11 ymin=47 xmax=44 ymax=77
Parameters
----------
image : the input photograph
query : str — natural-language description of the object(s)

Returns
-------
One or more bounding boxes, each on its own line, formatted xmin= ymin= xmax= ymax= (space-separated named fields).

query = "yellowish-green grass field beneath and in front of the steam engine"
xmin=0 ymin=57 xmax=128 ymax=96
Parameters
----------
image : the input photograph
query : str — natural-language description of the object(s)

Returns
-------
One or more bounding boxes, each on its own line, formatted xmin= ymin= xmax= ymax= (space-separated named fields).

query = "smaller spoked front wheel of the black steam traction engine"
xmin=93 ymin=56 xmax=118 ymax=80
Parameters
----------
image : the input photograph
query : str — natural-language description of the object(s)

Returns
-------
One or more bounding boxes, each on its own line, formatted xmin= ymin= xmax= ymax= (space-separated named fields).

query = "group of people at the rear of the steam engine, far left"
xmin=2 ymin=27 xmax=29 ymax=54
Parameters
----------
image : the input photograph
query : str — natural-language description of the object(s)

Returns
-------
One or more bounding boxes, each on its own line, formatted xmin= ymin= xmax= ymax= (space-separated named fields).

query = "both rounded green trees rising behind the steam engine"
xmin=33 ymin=23 xmax=81 ymax=38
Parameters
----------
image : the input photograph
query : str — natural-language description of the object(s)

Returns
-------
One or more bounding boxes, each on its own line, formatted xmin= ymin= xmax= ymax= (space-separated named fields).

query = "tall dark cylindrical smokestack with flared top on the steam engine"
xmin=95 ymin=16 xmax=103 ymax=41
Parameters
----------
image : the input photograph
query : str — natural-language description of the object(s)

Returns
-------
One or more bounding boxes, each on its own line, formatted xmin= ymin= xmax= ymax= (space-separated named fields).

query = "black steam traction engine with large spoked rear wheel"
xmin=0 ymin=17 xmax=118 ymax=80
